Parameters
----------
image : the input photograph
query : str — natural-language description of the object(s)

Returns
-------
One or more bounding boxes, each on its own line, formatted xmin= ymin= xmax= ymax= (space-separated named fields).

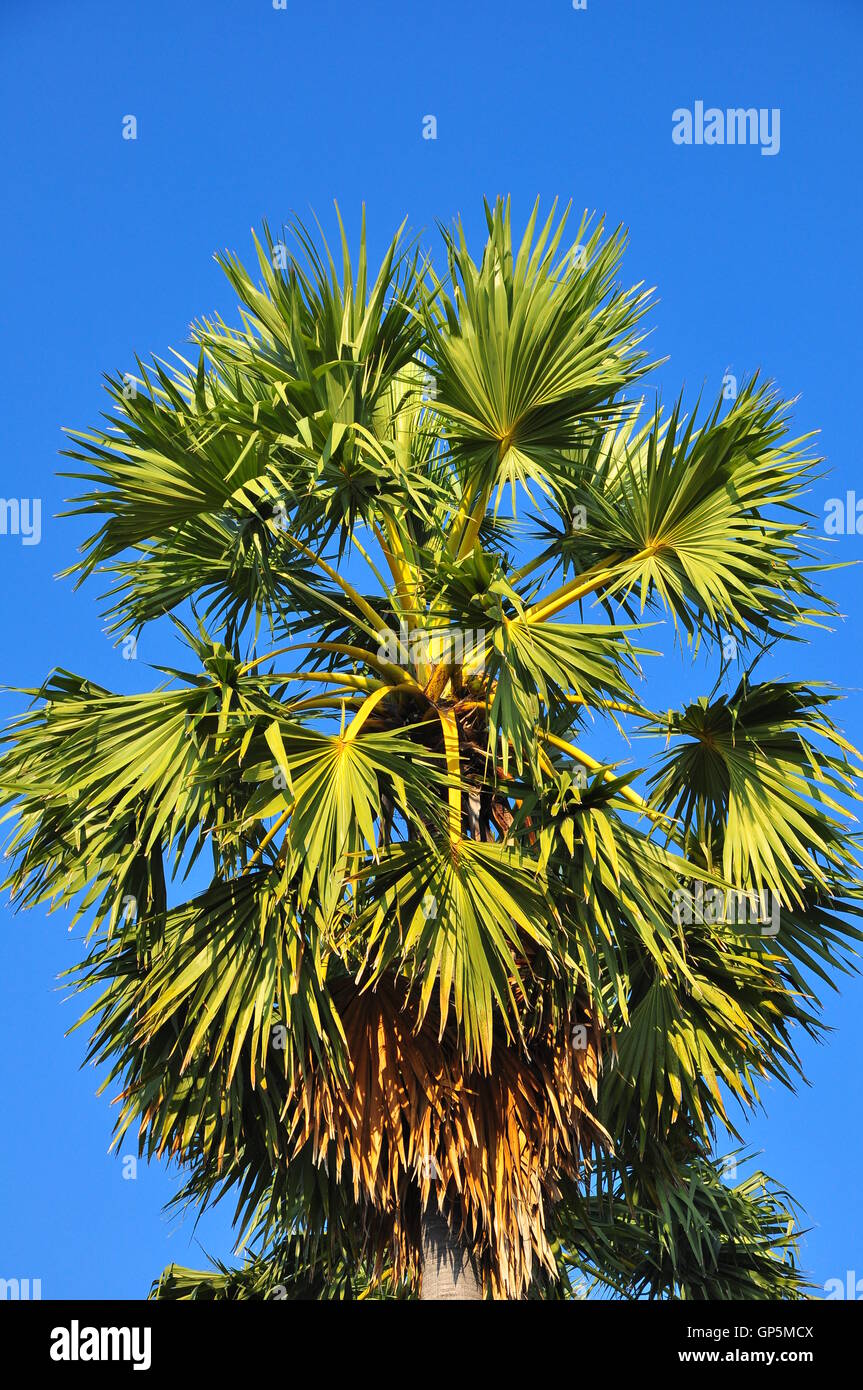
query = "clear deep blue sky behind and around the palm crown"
xmin=0 ymin=0 xmax=863 ymax=1297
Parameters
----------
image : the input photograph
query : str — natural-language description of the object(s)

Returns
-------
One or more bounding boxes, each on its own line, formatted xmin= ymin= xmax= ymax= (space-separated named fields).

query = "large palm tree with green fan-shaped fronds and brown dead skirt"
xmin=0 ymin=202 xmax=860 ymax=1298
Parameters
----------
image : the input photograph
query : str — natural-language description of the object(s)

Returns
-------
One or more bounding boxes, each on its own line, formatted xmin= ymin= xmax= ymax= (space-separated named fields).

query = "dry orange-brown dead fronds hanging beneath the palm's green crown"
xmin=286 ymin=983 xmax=607 ymax=1298
